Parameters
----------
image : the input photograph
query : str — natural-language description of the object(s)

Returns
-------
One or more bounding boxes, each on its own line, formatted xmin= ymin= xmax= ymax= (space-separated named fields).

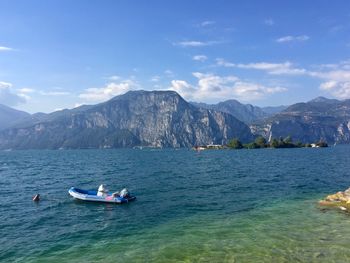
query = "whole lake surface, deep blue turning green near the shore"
xmin=0 ymin=146 xmax=350 ymax=262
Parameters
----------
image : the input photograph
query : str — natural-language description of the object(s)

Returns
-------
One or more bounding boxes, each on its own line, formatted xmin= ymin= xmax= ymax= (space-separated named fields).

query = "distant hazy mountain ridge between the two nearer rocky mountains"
xmin=191 ymin=100 xmax=269 ymax=124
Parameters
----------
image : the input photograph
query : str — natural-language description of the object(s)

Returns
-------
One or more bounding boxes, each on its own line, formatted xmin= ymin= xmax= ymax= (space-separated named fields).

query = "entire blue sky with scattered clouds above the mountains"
xmin=0 ymin=0 xmax=350 ymax=113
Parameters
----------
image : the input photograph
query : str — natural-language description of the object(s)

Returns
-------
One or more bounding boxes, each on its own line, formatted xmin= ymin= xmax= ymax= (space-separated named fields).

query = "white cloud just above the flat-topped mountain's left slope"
xmin=79 ymin=80 xmax=138 ymax=102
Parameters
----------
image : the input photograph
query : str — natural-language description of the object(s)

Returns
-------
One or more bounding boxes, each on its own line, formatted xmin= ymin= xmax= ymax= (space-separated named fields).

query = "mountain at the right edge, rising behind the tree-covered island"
xmin=251 ymin=97 xmax=350 ymax=143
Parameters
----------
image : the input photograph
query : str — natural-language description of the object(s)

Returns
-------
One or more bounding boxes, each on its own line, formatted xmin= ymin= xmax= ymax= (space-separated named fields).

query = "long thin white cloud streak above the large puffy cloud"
xmin=216 ymin=58 xmax=306 ymax=75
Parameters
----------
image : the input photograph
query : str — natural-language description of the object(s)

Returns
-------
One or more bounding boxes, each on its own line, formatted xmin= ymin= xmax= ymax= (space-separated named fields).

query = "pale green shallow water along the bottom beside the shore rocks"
xmin=27 ymin=199 xmax=350 ymax=262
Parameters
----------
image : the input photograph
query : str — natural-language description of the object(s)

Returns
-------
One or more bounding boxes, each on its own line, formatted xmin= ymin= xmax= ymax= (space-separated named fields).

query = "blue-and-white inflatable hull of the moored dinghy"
xmin=68 ymin=187 xmax=136 ymax=204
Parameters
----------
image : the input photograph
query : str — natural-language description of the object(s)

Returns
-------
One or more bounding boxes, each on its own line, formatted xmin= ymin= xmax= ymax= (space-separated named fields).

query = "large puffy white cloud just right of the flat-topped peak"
xmin=170 ymin=72 xmax=287 ymax=102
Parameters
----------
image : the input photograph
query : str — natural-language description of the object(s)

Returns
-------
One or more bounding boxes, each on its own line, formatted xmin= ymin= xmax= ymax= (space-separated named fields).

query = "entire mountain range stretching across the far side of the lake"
xmin=0 ymin=91 xmax=350 ymax=149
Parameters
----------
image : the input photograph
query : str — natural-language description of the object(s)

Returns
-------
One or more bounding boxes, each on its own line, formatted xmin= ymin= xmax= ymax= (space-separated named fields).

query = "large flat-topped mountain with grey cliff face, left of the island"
xmin=0 ymin=91 xmax=253 ymax=149
